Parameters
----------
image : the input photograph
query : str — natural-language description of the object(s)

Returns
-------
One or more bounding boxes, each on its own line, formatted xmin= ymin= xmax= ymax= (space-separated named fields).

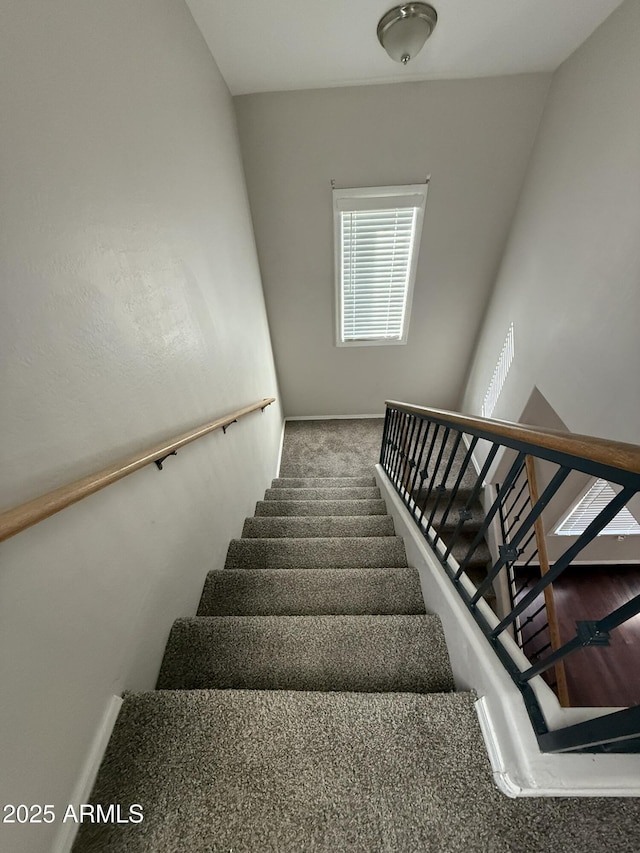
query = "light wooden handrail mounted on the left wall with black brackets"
xmin=0 ymin=397 xmax=276 ymax=542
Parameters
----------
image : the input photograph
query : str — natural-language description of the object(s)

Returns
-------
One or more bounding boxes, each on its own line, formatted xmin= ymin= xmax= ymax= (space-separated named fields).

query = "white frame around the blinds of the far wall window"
xmin=333 ymin=185 xmax=429 ymax=347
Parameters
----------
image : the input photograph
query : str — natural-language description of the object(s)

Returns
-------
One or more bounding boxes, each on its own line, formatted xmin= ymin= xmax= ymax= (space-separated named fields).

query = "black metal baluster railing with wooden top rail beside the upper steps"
xmin=380 ymin=401 xmax=640 ymax=752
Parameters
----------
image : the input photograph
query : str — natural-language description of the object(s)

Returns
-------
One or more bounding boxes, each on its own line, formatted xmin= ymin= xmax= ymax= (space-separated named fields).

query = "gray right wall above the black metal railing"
xmin=464 ymin=0 xmax=640 ymax=442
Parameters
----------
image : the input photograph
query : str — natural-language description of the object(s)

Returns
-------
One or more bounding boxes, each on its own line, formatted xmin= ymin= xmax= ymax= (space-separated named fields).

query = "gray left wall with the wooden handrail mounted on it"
xmin=0 ymin=0 xmax=281 ymax=853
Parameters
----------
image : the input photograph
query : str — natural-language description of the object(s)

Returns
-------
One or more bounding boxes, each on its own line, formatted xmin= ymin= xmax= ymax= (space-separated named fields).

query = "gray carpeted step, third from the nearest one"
xmin=198 ymin=569 xmax=424 ymax=616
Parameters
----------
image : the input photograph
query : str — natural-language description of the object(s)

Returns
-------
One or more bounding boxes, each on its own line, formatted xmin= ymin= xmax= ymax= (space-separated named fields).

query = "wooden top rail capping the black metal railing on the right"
xmin=386 ymin=400 xmax=640 ymax=474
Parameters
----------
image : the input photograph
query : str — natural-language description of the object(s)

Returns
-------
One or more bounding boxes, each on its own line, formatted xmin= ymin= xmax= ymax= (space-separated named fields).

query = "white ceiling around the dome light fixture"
xmin=186 ymin=0 xmax=622 ymax=95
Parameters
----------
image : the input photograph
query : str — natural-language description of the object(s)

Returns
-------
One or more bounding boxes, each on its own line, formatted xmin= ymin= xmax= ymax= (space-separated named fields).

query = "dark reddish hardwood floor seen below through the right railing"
xmin=516 ymin=565 xmax=640 ymax=707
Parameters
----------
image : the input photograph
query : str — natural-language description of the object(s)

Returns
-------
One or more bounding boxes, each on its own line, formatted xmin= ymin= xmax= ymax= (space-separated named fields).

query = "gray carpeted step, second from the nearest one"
xmin=157 ymin=615 xmax=454 ymax=693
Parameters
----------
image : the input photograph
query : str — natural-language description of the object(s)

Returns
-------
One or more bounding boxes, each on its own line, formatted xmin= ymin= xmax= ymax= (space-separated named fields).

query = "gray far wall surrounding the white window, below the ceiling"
xmin=234 ymin=75 xmax=550 ymax=415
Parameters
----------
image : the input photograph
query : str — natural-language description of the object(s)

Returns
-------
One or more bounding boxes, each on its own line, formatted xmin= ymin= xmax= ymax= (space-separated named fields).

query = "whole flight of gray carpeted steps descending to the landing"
xmin=74 ymin=477 xmax=473 ymax=853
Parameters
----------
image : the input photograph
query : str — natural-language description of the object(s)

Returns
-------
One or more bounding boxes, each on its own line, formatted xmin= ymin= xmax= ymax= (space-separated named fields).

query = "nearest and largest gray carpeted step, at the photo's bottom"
xmin=74 ymin=690 xmax=492 ymax=853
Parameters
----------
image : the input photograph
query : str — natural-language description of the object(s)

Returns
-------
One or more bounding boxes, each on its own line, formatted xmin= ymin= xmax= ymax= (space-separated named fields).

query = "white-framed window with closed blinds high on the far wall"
xmin=333 ymin=184 xmax=427 ymax=346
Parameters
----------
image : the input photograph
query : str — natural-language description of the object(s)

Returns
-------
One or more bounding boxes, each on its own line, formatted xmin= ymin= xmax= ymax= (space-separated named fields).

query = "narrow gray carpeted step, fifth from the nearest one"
xmin=242 ymin=515 xmax=395 ymax=539
